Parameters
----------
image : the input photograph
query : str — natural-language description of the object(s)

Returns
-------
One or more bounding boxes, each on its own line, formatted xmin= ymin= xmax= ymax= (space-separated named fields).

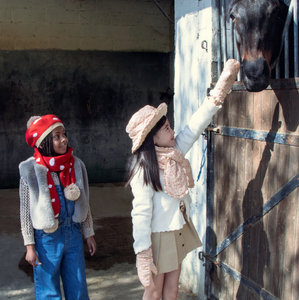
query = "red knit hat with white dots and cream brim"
xmin=26 ymin=115 xmax=64 ymax=148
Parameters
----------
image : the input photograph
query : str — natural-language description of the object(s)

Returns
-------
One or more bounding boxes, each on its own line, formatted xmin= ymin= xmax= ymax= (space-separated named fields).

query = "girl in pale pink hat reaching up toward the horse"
xmin=126 ymin=59 xmax=240 ymax=300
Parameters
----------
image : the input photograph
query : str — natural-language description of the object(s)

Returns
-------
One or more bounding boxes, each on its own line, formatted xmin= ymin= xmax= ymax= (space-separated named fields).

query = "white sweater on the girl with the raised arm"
xmin=131 ymin=99 xmax=220 ymax=253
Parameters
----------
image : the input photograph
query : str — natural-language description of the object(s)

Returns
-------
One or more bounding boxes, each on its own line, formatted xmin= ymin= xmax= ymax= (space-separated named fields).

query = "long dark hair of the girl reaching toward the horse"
xmin=125 ymin=116 xmax=167 ymax=192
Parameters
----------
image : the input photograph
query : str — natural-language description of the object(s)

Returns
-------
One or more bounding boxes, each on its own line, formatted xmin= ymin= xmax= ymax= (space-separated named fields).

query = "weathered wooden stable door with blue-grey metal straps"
xmin=203 ymin=78 xmax=299 ymax=300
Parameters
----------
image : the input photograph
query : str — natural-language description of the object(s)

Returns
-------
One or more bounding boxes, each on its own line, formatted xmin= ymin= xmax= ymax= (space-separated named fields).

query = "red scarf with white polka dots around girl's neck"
xmin=34 ymin=148 xmax=76 ymax=218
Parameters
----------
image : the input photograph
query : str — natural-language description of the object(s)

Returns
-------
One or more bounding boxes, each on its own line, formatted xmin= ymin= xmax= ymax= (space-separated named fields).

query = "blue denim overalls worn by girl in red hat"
xmin=34 ymin=179 xmax=89 ymax=300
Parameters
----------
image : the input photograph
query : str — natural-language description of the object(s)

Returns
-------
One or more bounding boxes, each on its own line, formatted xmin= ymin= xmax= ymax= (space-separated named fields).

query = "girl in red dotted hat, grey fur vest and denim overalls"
xmin=19 ymin=115 xmax=96 ymax=300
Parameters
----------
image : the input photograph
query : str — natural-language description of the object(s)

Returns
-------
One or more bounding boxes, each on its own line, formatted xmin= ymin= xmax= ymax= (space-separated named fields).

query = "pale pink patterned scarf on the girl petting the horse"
xmin=155 ymin=146 xmax=194 ymax=199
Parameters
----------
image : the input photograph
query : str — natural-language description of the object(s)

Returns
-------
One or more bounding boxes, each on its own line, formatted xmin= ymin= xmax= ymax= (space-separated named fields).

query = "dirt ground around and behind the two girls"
xmin=0 ymin=184 xmax=200 ymax=300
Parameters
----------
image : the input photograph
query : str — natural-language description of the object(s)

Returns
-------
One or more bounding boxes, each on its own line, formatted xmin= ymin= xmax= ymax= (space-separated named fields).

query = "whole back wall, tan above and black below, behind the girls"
xmin=0 ymin=0 xmax=174 ymax=188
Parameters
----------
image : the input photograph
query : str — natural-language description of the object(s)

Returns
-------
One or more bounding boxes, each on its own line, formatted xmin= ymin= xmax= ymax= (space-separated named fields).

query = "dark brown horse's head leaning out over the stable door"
xmin=229 ymin=0 xmax=288 ymax=92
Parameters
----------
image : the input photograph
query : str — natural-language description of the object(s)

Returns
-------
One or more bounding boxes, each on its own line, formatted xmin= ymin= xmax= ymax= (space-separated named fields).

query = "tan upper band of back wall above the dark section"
xmin=0 ymin=0 xmax=173 ymax=52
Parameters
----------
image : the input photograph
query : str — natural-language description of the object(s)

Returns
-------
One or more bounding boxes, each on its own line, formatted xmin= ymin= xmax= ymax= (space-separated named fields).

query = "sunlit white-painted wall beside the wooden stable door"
xmin=174 ymin=0 xmax=212 ymax=299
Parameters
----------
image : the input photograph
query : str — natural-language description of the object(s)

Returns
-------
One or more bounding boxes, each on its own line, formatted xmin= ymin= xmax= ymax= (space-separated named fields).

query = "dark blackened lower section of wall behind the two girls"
xmin=0 ymin=51 xmax=173 ymax=188
